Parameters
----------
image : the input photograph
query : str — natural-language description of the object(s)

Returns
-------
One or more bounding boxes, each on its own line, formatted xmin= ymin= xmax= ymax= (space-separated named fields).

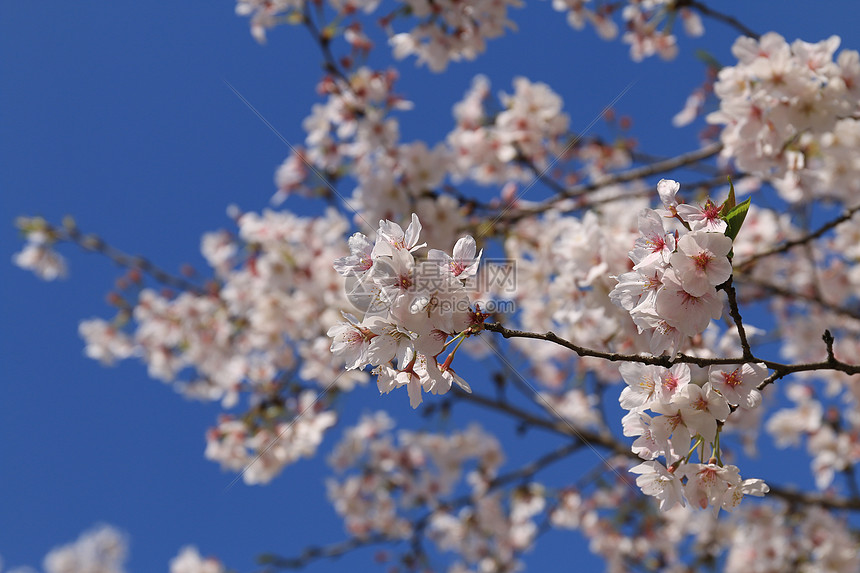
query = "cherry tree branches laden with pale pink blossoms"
xmin=14 ymin=0 xmax=860 ymax=573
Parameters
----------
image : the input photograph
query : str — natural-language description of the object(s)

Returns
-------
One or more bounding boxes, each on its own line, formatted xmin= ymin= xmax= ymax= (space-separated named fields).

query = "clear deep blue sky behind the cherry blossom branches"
xmin=5 ymin=0 xmax=860 ymax=571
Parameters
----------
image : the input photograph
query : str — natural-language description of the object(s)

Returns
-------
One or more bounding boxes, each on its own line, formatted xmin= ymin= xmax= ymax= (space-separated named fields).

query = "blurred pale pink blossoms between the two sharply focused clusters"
xmin=505 ymin=194 xmax=647 ymax=389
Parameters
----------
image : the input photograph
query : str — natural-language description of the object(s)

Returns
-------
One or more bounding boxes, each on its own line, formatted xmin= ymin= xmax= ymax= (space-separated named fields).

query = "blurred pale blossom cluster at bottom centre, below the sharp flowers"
xmin=328 ymin=412 xmax=545 ymax=572
